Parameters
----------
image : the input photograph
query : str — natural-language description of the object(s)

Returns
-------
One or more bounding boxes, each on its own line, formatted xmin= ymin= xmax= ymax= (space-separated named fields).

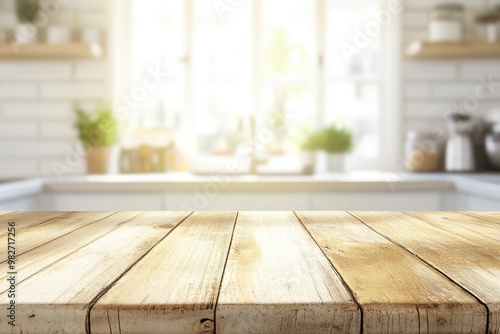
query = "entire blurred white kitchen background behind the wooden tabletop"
xmin=0 ymin=0 xmax=500 ymax=210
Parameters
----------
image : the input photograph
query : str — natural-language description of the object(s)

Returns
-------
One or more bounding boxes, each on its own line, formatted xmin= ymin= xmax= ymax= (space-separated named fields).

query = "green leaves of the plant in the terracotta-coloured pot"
xmin=75 ymin=107 xmax=118 ymax=148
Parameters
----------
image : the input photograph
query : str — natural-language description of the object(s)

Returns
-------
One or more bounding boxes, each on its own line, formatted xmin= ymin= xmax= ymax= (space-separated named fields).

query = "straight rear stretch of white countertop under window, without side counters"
xmin=44 ymin=172 xmax=454 ymax=191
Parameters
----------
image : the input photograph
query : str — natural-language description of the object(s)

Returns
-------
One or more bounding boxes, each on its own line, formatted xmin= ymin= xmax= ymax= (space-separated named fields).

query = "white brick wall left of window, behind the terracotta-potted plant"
xmin=0 ymin=0 xmax=112 ymax=179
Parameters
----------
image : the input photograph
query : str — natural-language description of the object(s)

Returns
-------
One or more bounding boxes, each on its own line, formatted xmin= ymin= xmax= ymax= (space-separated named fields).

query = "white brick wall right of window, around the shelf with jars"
xmin=400 ymin=0 xmax=500 ymax=155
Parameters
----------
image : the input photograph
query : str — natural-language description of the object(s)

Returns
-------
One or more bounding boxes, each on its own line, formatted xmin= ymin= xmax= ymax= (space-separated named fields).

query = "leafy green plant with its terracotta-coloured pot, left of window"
xmin=75 ymin=107 xmax=118 ymax=174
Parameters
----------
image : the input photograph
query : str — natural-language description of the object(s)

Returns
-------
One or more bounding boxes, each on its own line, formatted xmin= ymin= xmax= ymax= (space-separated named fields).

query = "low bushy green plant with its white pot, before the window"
xmin=302 ymin=125 xmax=353 ymax=172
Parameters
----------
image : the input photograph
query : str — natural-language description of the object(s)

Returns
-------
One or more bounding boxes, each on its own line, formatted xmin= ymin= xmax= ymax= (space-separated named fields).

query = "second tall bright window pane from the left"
xmin=192 ymin=1 xmax=252 ymax=154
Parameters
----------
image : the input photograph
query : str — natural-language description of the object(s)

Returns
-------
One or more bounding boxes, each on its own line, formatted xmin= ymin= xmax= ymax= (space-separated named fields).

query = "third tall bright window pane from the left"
xmin=258 ymin=0 xmax=316 ymax=152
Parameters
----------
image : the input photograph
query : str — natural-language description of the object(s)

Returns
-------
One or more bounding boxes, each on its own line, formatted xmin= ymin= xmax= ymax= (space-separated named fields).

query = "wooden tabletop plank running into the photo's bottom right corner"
xmin=353 ymin=212 xmax=500 ymax=333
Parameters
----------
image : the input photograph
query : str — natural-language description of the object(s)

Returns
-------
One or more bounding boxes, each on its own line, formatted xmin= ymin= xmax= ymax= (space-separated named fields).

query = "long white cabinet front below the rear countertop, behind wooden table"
xmin=41 ymin=191 xmax=450 ymax=211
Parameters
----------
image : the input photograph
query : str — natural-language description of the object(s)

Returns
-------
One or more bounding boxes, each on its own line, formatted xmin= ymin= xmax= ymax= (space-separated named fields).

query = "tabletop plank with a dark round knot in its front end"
xmin=91 ymin=212 xmax=236 ymax=334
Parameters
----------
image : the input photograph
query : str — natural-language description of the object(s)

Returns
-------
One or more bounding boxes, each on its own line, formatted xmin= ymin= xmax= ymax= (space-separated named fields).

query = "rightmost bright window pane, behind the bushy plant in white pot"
xmin=324 ymin=0 xmax=383 ymax=157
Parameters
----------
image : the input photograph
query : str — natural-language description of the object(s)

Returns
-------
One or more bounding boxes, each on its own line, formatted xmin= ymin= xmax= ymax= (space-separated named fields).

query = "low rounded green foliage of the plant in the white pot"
xmin=302 ymin=125 xmax=353 ymax=153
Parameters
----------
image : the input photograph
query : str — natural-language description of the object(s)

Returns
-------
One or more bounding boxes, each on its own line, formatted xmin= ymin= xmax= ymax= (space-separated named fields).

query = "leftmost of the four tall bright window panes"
xmin=128 ymin=0 xmax=186 ymax=128
